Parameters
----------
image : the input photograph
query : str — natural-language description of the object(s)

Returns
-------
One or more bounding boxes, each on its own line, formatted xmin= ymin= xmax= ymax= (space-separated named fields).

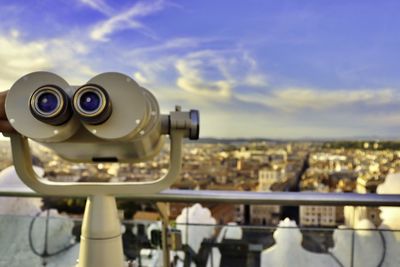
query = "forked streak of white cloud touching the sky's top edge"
xmin=90 ymin=1 xmax=164 ymax=41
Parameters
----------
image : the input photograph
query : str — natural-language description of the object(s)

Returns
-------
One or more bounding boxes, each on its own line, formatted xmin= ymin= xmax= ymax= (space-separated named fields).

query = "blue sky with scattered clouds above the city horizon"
xmin=0 ymin=0 xmax=400 ymax=138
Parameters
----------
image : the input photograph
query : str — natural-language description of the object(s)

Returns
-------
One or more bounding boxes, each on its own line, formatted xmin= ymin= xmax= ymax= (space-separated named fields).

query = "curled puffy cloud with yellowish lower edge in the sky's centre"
xmin=175 ymin=50 xmax=267 ymax=98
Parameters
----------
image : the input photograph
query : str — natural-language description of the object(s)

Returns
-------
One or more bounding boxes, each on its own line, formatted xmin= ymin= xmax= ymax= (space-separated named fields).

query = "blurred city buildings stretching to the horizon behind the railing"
xmin=0 ymin=139 xmax=400 ymax=230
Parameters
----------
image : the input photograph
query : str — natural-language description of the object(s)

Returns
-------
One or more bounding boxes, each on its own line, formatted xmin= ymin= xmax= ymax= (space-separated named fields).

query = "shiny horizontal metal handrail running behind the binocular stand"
xmin=0 ymin=187 xmax=400 ymax=207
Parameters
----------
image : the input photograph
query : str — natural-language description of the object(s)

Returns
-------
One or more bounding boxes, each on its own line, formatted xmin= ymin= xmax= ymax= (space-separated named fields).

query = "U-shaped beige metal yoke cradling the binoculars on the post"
xmin=9 ymin=129 xmax=185 ymax=196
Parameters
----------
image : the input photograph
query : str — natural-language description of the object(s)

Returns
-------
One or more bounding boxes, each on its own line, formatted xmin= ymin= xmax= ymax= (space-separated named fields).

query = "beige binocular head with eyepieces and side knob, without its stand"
xmin=6 ymin=72 xmax=199 ymax=162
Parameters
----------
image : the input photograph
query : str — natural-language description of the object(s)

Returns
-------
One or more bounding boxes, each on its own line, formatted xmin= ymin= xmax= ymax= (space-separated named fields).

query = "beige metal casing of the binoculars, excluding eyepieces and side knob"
xmin=6 ymin=72 xmax=165 ymax=162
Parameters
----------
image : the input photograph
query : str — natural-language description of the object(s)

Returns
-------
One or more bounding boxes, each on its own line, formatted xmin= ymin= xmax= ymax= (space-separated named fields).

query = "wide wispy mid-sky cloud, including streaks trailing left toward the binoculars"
xmin=128 ymin=46 xmax=268 ymax=101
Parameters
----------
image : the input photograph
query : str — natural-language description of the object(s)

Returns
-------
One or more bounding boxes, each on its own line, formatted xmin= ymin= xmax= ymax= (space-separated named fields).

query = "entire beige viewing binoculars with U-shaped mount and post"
xmin=6 ymin=72 xmax=199 ymax=267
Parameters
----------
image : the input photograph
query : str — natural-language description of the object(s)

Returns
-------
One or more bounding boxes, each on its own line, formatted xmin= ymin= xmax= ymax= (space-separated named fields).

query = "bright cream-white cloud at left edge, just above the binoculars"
xmin=0 ymin=30 xmax=95 ymax=90
